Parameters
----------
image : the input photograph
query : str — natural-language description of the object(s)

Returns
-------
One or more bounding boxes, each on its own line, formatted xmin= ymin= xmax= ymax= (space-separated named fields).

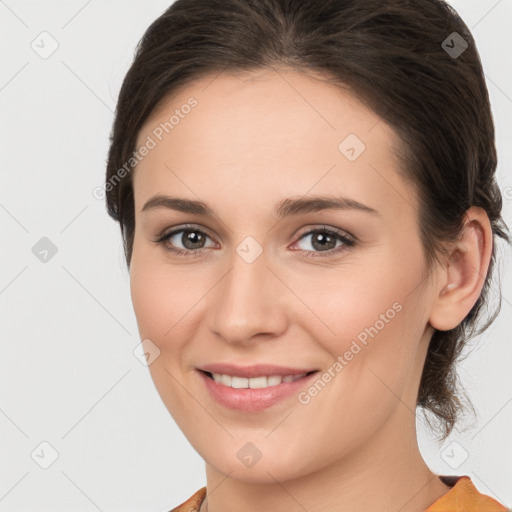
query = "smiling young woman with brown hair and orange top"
xmin=106 ymin=0 xmax=510 ymax=512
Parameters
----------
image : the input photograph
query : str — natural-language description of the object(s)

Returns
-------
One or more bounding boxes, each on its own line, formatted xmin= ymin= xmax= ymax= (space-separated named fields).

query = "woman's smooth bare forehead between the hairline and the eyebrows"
xmin=134 ymin=69 xmax=416 ymax=218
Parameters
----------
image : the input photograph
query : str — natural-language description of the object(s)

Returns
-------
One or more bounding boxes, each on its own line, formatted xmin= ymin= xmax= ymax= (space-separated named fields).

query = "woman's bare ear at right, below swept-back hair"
xmin=429 ymin=206 xmax=493 ymax=331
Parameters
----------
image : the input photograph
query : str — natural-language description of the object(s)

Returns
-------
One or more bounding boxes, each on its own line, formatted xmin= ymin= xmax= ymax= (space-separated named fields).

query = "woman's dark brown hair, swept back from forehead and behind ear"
xmin=106 ymin=0 xmax=510 ymax=439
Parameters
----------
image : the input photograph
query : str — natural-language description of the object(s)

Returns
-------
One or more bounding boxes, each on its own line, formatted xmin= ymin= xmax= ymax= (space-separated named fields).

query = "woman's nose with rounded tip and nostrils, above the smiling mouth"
xmin=208 ymin=246 xmax=291 ymax=344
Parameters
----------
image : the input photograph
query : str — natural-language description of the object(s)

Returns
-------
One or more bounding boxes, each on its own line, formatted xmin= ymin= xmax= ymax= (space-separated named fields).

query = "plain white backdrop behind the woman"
xmin=0 ymin=0 xmax=512 ymax=512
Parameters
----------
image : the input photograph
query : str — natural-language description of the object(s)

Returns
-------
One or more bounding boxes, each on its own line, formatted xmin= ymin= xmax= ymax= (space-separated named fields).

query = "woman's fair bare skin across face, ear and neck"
xmin=130 ymin=68 xmax=492 ymax=512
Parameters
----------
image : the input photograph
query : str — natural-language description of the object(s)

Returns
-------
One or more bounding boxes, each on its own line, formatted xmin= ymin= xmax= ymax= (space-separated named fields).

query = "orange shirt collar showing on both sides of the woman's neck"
xmin=170 ymin=476 xmax=512 ymax=512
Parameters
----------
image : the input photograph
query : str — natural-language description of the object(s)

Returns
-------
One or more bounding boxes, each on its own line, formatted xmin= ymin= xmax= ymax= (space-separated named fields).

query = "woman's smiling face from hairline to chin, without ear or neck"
xmin=130 ymin=70 xmax=440 ymax=482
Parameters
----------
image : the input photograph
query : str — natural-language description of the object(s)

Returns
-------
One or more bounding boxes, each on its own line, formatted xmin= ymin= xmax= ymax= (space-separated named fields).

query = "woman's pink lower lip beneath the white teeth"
xmin=198 ymin=370 xmax=318 ymax=412
